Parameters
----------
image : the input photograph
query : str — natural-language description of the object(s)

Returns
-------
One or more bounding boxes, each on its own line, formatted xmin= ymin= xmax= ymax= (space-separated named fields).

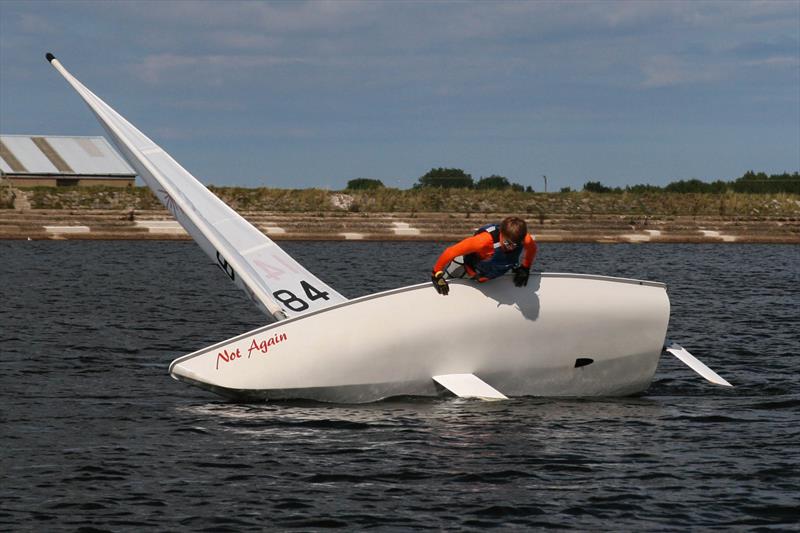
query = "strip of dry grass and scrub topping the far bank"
xmin=7 ymin=186 xmax=800 ymax=220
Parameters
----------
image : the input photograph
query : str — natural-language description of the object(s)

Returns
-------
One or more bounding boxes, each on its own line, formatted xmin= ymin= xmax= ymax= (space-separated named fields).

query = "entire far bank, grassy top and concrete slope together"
xmin=0 ymin=184 xmax=800 ymax=243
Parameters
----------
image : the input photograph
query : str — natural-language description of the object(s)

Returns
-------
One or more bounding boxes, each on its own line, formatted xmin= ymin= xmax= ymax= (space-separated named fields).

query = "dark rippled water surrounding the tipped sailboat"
xmin=0 ymin=241 xmax=800 ymax=531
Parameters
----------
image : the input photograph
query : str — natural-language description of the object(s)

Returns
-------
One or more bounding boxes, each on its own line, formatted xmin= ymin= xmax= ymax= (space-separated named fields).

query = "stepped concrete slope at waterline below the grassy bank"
xmin=0 ymin=206 xmax=800 ymax=244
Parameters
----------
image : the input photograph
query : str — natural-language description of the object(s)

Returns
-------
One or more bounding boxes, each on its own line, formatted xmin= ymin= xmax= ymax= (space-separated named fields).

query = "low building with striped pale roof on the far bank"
xmin=0 ymin=135 xmax=136 ymax=187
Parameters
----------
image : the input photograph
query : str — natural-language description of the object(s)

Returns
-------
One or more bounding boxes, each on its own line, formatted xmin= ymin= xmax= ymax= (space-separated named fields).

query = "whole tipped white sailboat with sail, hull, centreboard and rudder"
xmin=47 ymin=53 xmax=730 ymax=403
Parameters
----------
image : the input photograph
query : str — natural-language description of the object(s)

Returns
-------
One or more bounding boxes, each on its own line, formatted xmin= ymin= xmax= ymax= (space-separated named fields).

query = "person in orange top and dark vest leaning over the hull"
xmin=431 ymin=217 xmax=537 ymax=296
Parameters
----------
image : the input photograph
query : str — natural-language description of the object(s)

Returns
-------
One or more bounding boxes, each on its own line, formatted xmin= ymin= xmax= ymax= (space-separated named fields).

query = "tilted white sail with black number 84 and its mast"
xmin=47 ymin=54 xmax=347 ymax=320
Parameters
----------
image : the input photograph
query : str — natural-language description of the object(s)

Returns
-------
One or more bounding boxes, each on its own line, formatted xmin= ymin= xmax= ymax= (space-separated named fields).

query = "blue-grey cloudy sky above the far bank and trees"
xmin=0 ymin=0 xmax=800 ymax=191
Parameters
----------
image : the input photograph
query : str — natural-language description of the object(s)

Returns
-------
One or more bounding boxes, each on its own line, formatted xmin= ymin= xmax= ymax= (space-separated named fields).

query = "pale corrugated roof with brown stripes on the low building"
xmin=0 ymin=135 xmax=136 ymax=177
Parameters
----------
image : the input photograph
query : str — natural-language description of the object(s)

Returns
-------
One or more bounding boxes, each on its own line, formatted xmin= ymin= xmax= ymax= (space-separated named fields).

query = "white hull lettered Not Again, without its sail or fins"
xmin=170 ymin=274 xmax=669 ymax=403
